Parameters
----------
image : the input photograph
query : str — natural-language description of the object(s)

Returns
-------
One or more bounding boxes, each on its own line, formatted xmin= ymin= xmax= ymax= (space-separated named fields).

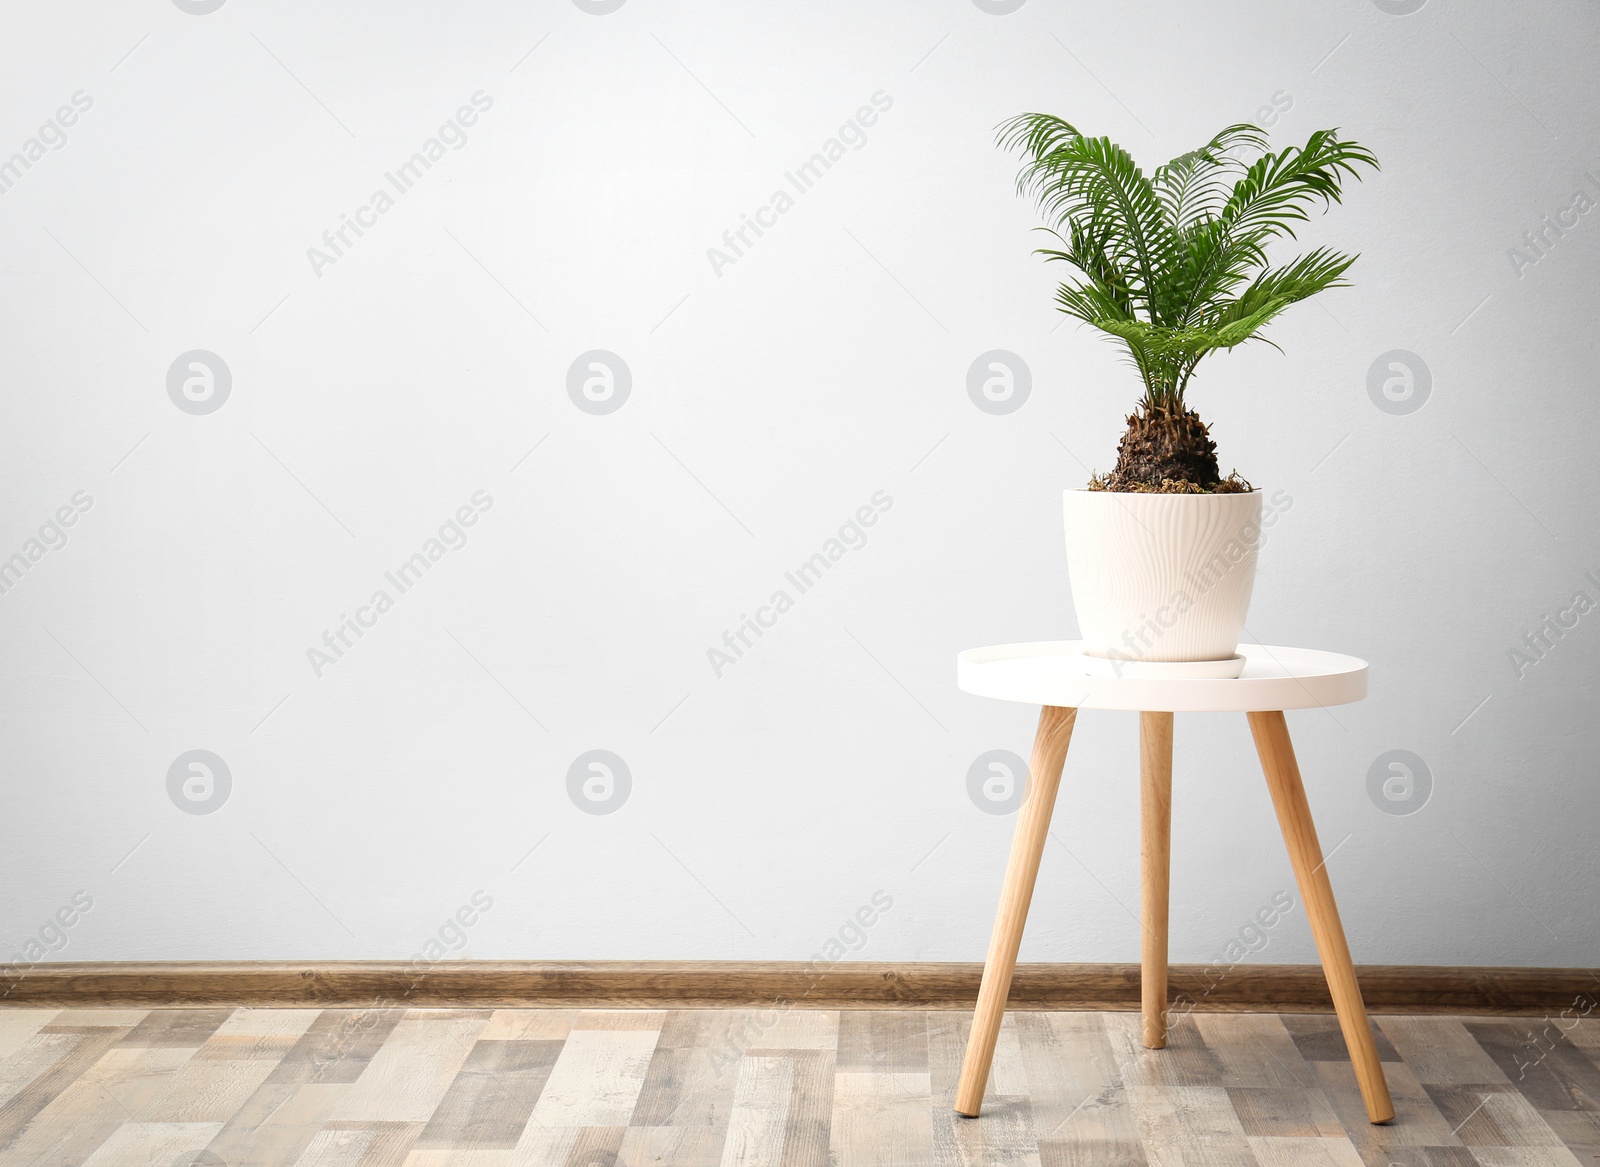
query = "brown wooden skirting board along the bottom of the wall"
xmin=0 ymin=960 xmax=1600 ymax=1017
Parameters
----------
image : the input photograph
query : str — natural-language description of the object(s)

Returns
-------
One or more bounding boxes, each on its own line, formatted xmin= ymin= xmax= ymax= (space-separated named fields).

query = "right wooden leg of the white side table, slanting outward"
xmin=1248 ymin=712 xmax=1395 ymax=1122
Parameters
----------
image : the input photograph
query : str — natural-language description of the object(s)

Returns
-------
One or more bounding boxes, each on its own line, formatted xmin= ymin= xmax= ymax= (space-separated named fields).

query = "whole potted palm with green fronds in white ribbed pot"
xmin=1000 ymin=114 xmax=1378 ymax=676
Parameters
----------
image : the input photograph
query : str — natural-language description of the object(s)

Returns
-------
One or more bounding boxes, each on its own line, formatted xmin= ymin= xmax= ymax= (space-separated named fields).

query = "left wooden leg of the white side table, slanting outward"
xmin=955 ymin=704 xmax=1078 ymax=1117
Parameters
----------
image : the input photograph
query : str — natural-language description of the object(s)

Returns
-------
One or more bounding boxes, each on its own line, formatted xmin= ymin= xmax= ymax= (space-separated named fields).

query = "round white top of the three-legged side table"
xmin=955 ymin=640 xmax=1366 ymax=712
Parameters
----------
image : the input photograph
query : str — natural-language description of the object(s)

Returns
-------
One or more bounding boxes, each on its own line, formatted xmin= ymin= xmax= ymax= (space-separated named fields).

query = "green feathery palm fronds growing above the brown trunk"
xmin=998 ymin=114 xmax=1378 ymax=408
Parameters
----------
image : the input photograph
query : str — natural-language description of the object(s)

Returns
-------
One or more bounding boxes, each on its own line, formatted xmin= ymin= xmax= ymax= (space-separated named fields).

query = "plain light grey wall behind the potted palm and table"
xmin=0 ymin=0 xmax=1600 ymax=965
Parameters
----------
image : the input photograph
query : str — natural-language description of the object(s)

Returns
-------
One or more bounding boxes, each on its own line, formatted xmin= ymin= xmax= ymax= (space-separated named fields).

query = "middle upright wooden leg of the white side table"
xmin=1139 ymin=712 xmax=1173 ymax=1050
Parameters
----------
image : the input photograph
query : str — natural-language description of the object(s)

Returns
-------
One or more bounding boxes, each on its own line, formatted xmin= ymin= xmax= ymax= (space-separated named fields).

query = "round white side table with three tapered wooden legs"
xmin=955 ymin=640 xmax=1395 ymax=1122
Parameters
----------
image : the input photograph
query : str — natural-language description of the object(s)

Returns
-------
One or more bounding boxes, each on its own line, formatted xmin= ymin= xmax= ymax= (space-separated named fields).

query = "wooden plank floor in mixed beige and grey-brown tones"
xmin=0 ymin=1009 xmax=1600 ymax=1167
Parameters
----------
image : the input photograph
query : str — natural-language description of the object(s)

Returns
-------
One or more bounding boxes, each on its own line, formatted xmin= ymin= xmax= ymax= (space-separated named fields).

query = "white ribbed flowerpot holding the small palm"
xmin=1062 ymin=490 xmax=1261 ymax=663
